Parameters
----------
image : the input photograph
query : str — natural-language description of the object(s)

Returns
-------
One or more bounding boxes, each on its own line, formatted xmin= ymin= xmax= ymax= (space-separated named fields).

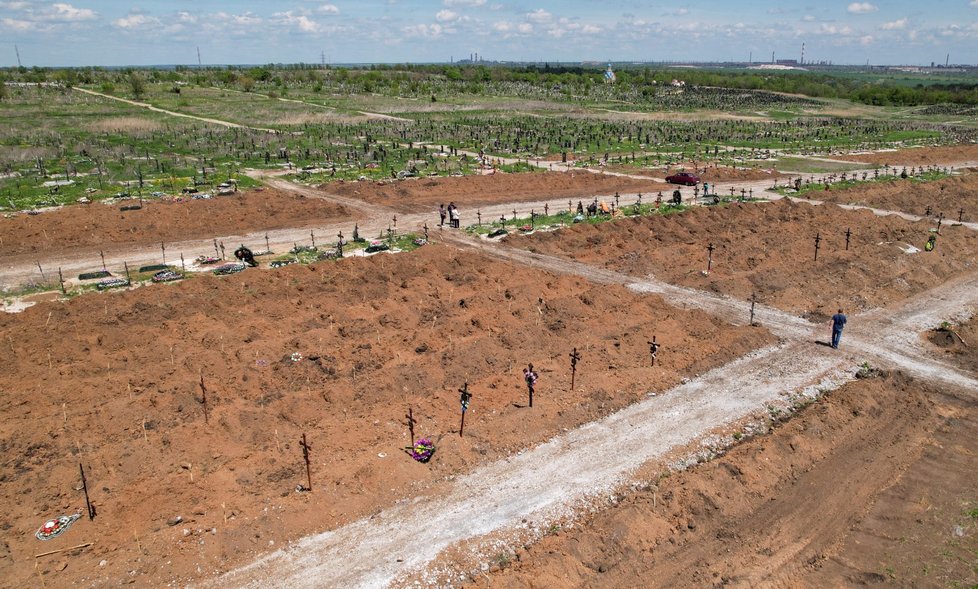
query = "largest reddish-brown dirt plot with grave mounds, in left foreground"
xmin=0 ymin=246 xmax=772 ymax=587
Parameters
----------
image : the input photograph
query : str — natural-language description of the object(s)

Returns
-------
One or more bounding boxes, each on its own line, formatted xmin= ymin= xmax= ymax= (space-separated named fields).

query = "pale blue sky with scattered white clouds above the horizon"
xmin=0 ymin=0 xmax=978 ymax=67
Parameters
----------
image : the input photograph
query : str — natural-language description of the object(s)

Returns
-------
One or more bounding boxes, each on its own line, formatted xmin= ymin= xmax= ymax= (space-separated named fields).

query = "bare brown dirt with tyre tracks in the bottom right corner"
xmin=474 ymin=374 xmax=978 ymax=589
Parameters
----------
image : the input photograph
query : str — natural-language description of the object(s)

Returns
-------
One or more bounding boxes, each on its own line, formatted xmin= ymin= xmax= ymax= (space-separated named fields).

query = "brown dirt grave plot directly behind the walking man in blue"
xmin=504 ymin=200 xmax=978 ymax=321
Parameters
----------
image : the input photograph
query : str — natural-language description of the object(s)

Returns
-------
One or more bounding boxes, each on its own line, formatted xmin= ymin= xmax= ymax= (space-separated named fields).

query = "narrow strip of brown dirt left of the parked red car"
xmin=321 ymin=172 xmax=662 ymax=213
